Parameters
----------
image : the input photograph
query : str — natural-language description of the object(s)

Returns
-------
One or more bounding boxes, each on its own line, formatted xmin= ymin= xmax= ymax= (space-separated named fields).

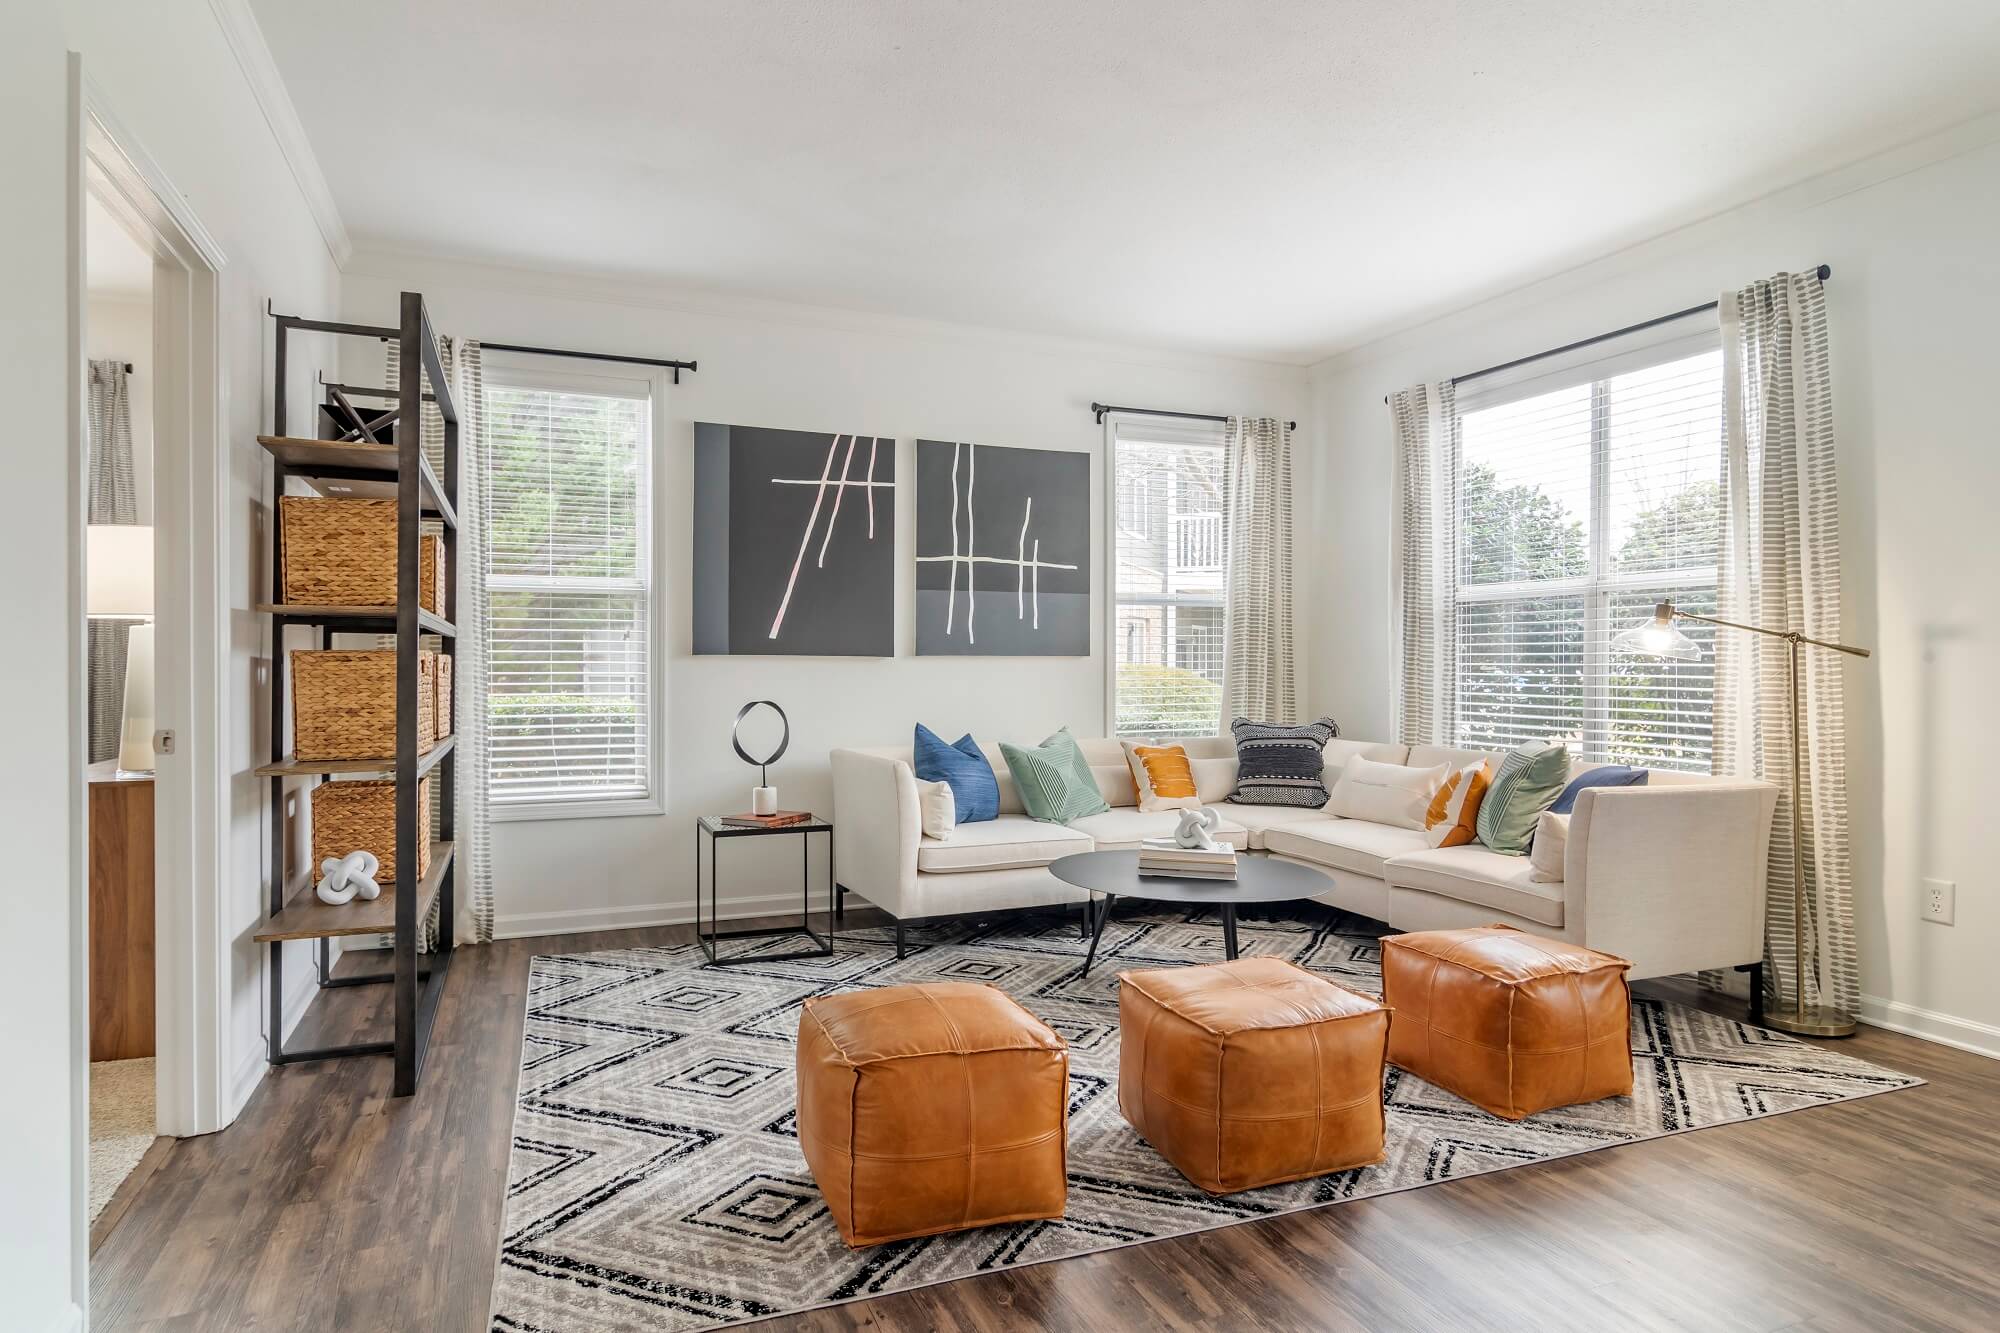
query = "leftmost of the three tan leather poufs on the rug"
xmin=798 ymin=983 xmax=1070 ymax=1247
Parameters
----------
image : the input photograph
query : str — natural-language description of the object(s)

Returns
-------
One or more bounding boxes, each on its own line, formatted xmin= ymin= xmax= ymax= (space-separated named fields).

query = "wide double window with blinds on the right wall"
xmin=1456 ymin=322 xmax=1724 ymax=773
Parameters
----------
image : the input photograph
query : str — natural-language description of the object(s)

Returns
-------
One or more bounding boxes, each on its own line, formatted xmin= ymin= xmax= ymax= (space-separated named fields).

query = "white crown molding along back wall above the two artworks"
xmin=342 ymin=248 xmax=1306 ymax=390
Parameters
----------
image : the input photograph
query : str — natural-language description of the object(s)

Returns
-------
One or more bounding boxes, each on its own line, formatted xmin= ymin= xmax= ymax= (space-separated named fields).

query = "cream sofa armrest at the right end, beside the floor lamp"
xmin=1562 ymin=783 xmax=1778 ymax=979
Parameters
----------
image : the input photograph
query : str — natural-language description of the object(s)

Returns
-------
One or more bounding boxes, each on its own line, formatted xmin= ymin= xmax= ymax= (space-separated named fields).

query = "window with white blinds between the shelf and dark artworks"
xmin=486 ymin=366 xmax=654 ymax=813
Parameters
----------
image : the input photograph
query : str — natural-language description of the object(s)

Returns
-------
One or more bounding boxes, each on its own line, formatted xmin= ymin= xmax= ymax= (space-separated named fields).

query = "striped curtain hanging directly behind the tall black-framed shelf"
xmin=386 ymin=334 xmax=494 ymax=945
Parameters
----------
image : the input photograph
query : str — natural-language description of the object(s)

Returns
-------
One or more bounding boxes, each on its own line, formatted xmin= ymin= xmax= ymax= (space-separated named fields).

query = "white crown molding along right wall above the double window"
xmin=1306 ymin=112 xmax=2000 ymax=384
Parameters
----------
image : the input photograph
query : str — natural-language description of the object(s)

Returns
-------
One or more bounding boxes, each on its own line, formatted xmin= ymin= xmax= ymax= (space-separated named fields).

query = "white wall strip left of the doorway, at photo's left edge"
xmin=0 ymin=8 xmax=82 ymax=1333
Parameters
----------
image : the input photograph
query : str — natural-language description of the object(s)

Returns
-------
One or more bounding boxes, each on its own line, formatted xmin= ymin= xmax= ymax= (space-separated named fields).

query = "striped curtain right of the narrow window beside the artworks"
xmin=1222 ymin=416 xmax=1298 ymax=723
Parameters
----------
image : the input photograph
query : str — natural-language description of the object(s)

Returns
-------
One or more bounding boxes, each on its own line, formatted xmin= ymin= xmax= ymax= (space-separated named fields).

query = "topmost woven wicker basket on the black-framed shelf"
xmin=278 ymin=494 xmax=446 ymax=614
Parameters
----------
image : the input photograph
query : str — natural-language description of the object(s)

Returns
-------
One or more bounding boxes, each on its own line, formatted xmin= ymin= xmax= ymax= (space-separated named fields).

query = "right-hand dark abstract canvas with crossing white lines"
xmin=916 ymin=440 xmax=1090 ymax=656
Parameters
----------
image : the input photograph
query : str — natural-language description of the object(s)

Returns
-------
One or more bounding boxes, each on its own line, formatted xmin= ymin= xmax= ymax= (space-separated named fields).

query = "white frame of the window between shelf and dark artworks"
xmin=482 ymin=352 xmax=670 ymax=823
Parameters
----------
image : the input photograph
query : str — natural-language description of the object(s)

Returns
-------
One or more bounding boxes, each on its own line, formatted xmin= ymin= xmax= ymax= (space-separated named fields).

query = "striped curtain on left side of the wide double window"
xmin=1388 ymin=380 xmax=1458 ymax=745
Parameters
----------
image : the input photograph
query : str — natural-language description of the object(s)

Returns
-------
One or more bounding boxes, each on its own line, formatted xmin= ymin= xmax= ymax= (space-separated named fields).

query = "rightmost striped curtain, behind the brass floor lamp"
xmin=1716 ymin=272 xmax=1860 ymax=1013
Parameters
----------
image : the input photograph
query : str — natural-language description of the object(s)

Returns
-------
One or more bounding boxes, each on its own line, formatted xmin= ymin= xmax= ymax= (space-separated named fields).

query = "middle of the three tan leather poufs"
xmin=1118 ymin=959 xmax=1390 ymax=1195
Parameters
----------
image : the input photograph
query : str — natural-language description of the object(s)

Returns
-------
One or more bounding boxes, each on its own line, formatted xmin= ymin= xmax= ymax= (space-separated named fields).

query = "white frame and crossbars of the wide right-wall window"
xmin=1450 ymin=312 xmax=1726 ymax=773
